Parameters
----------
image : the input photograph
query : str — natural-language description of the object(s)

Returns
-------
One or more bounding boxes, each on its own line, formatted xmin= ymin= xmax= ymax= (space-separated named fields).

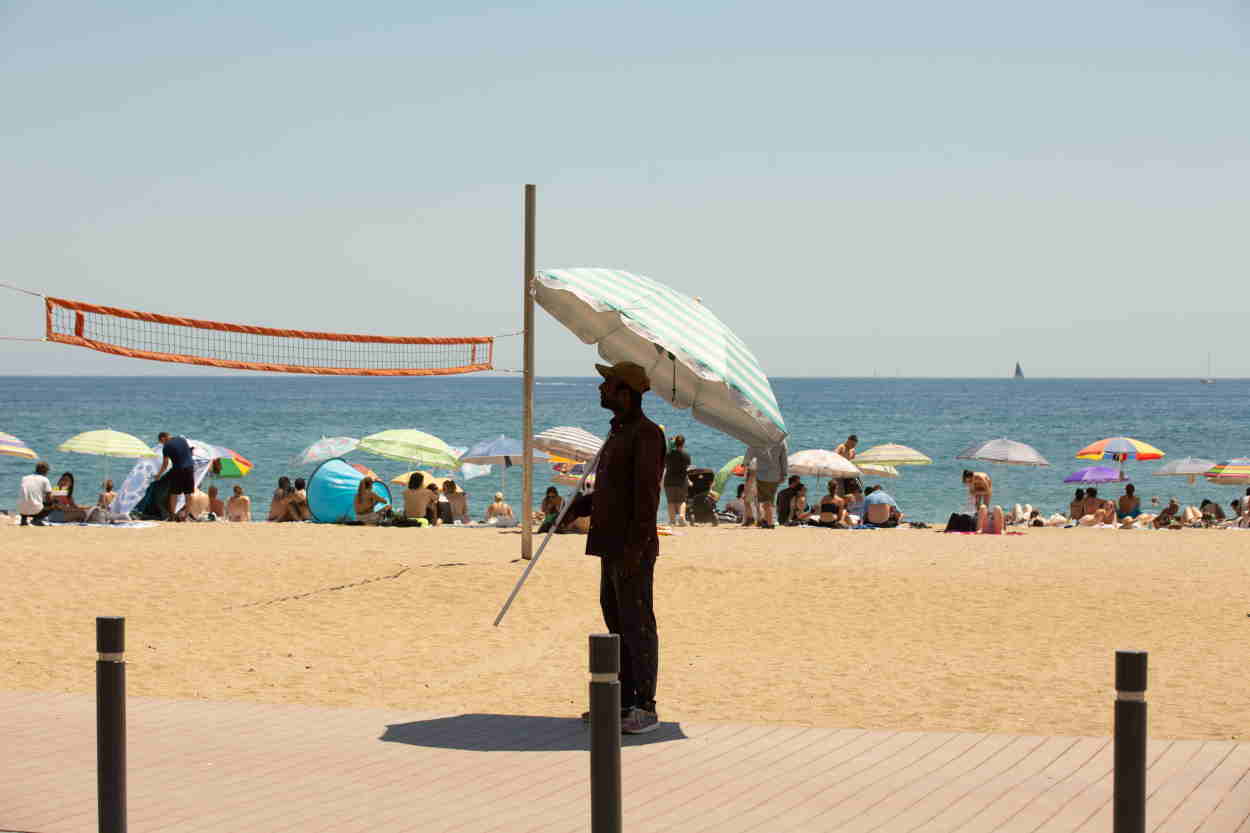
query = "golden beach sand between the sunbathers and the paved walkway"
xmin=0 ymin=519 xmax=1250 ymax=738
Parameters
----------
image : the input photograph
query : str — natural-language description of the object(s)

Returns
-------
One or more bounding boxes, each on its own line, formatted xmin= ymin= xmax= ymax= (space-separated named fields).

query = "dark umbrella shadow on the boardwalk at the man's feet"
xmin=378 ymin=714 xmax=686 ymax=752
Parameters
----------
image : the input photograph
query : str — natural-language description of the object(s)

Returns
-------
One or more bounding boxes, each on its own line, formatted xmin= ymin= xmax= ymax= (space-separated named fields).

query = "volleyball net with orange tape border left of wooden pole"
xmin=44 ymin=298 xmax=495 ymax=376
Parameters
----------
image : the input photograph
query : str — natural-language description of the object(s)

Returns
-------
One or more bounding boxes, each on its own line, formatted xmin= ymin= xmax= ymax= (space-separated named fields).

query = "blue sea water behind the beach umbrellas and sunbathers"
xmin=0 ymin=374 xmax=1250 ymax=523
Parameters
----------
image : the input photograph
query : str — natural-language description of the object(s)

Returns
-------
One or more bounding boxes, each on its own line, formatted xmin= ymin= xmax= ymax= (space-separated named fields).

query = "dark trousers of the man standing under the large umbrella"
xmin=599 ymin=548 xmax=660 ymax=710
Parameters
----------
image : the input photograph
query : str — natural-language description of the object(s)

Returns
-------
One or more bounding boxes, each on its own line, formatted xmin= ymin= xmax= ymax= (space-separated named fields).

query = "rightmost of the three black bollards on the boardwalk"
xmin=1111 ymin=650 xmax=1146 ymax=833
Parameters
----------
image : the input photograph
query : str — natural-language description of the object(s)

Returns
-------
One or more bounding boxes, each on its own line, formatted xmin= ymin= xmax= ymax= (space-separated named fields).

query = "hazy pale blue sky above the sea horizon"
xmin=0 ymin=0 xmax=1250 ymax=376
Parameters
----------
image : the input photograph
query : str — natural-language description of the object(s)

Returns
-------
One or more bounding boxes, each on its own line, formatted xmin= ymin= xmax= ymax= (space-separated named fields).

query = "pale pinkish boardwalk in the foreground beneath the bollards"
xmin=0 ymin=693 xmax=1250 ymax=833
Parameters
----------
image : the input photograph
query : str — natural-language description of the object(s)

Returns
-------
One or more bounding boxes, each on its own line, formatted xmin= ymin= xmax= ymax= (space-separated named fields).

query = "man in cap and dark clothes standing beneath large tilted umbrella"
xmin=569 ymin=361 xmax=664 ymax=734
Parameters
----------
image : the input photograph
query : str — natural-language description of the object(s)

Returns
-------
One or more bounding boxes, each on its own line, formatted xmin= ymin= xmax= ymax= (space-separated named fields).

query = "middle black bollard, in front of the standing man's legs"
xmin=590 ymin=633 xmax=621 ymax=833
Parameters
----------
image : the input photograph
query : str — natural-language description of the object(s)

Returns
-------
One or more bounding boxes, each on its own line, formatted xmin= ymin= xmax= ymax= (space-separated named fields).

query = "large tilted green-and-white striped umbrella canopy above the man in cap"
xmin=534 ymin=269 xmax=786 ymax=445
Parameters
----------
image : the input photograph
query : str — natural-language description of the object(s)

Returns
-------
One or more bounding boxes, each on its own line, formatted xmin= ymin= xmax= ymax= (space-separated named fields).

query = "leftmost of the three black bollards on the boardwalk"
xmin=95 ymin=617 xmax=126 ymax=833
